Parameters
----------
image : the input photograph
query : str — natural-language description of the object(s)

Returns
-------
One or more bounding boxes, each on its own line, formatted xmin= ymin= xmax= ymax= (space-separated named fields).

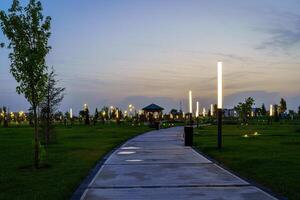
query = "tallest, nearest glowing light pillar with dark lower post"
xmin=217 ymin=62 xmax=223 ymax=149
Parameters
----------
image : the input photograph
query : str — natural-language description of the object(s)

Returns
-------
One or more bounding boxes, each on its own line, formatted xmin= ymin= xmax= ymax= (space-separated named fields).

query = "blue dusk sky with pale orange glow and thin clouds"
xmin=0 ymin=0 xmax=300 ymax=112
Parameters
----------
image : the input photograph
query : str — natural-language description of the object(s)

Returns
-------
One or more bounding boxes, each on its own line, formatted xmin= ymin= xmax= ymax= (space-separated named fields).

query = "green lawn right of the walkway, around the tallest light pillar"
xmin=195 ymin=124 xmax=300 ymax=200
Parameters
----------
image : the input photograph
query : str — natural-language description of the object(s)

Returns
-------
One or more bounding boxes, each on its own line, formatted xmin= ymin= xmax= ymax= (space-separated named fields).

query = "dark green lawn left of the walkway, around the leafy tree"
xmin=0 ymin=124 xmax=149 ymax=200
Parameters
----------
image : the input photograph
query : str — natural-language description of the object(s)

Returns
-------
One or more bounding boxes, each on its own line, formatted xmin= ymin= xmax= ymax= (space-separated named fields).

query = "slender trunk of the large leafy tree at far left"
xmin=33 ymin=105 xmax=40 ymax=169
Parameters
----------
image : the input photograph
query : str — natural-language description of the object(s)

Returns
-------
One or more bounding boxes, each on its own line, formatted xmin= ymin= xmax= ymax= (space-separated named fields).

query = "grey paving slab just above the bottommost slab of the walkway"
xmin=90 ymin=164 xmax=248 ymax=187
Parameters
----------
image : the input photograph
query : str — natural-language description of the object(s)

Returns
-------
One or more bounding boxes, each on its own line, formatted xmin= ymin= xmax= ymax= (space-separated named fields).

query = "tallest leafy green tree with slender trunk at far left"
xmin=0 ymin=0 xmax=51 ymax=168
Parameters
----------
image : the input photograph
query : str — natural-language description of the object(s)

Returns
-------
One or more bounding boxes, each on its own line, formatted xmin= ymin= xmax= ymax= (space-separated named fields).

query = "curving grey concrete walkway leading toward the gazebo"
xmin=81 ymin=127 xmax=275 ymax=200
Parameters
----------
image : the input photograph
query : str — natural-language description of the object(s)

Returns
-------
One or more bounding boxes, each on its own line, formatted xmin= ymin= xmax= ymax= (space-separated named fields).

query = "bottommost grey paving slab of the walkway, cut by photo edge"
xmin=85 ymin=186 xmax=274 ymax=200
